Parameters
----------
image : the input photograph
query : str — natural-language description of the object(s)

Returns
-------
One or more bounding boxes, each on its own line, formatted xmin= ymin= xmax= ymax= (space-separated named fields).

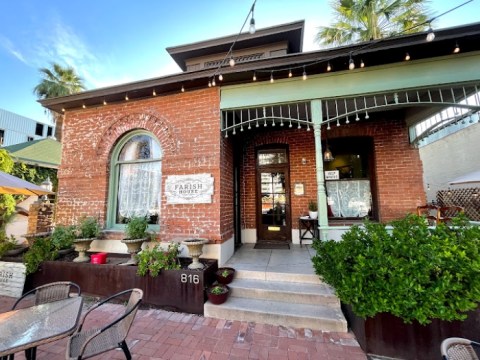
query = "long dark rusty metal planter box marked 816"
xmin=24 ymin=256 xmax=218 ymax=315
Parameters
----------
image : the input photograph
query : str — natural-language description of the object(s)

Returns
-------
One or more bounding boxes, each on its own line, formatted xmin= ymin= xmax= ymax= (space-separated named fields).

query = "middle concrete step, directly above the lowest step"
xmin=229 ymin=278 xmax=340 ymax=308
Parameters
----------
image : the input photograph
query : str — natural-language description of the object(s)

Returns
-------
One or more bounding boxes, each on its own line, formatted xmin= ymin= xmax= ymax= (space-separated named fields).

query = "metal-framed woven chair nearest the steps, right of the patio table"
xmin=66 ymin=289 xmax=143 ymax=360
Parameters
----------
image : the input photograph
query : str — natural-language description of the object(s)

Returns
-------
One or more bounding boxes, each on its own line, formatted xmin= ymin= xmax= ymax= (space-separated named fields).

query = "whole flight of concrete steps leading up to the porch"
xmin=204 ymin=270 xmax=347 ymax=332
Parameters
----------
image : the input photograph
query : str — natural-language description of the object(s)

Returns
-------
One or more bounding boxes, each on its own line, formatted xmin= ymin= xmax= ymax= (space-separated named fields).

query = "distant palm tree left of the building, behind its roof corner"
xmin=33 ymin=63 xmax=85 ymax=141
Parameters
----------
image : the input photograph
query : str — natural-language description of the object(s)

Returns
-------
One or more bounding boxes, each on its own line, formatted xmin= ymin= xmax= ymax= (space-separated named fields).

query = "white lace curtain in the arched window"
xmin=118 ymin=161 xmax=162 ymax=218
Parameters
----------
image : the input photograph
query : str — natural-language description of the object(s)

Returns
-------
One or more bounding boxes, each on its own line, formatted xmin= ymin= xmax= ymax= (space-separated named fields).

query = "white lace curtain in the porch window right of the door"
xmin=326 ymin=180 xmax=372 ymax=218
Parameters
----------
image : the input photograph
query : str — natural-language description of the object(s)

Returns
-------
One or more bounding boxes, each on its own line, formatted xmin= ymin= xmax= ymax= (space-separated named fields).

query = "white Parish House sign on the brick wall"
xmin=165 ymin=174 xmax=213 ymax=204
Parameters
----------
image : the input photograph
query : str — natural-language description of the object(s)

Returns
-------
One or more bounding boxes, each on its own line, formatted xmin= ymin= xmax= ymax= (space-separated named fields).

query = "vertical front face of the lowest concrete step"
xmin=204 ymin=303 xmax=347 ymax=332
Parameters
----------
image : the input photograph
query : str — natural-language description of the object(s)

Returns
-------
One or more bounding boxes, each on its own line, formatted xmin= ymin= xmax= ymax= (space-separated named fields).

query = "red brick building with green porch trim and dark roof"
xmin=42 ymin=22 xmax=480 ymax=262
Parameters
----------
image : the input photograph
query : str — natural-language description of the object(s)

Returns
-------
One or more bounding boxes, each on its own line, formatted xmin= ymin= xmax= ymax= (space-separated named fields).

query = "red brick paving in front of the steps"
xmin=0 ymin=297 xmax=367 ymax=360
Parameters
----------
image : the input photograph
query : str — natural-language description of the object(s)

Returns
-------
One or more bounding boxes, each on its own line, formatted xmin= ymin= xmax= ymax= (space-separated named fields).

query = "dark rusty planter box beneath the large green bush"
xmin=342 ymin=304 xmax=480 ymax=360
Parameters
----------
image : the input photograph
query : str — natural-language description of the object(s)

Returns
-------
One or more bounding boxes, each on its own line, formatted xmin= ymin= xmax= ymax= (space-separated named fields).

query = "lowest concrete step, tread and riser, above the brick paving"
xmin=204 ymin=296 xmax=347 ymax=332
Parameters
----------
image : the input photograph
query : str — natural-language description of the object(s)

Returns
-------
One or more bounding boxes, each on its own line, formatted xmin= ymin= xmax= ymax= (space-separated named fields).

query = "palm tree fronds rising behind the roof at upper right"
xmin=316 ymin=0 xmax=428 ymax=45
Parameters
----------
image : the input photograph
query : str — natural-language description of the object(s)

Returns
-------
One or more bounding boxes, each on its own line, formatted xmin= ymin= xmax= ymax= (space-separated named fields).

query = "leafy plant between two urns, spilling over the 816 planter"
xmin=137 ymin=243 xmax=180 ymax=277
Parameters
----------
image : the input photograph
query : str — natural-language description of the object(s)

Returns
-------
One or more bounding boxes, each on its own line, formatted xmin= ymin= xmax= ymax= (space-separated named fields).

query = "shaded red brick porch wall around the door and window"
xmin=242 ymin=113 xmax=426 ymax=229
